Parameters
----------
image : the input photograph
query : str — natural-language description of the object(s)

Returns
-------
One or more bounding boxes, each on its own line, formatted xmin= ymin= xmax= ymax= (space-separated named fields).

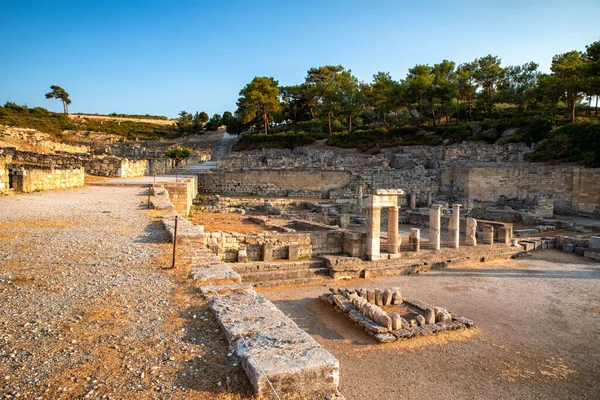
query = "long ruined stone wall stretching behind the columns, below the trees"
xmin=210 ymin=142 xmax=600 ymax=215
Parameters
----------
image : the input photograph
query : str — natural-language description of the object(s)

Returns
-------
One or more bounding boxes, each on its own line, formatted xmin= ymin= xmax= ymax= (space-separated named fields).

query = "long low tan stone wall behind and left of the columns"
xmin=198 ymin=169 xmax=351 ymax=198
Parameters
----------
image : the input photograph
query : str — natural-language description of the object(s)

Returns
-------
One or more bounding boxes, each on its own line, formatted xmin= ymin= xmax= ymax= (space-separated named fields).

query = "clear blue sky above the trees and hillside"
xmin=0 ymin=0 xmax=600 ymax=117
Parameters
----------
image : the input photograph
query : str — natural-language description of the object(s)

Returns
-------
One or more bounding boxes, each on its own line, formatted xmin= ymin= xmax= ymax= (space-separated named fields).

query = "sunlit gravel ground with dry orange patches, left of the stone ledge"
xmin=0 ymin=187 xmax=251 ymax=399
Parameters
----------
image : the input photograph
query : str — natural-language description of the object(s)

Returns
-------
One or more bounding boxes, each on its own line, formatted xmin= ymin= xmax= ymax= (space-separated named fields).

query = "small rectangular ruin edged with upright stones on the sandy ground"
xmin=320 ymin=288 xmax=475 ymax=343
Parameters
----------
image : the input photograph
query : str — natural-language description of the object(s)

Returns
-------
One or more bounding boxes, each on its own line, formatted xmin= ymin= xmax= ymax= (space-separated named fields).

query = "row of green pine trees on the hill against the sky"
xmin=231 ymin=41 xmax=600 ymax=135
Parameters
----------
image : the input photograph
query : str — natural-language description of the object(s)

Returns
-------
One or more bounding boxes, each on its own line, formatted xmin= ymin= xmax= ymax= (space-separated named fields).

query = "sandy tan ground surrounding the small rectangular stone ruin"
xmin=260 ymin=251 xmax=600 ymax=400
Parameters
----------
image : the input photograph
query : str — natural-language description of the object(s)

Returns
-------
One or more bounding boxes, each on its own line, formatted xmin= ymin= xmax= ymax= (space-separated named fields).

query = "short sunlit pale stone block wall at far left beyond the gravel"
xmin=12 ymin=167 xmax=85 ymax=192
